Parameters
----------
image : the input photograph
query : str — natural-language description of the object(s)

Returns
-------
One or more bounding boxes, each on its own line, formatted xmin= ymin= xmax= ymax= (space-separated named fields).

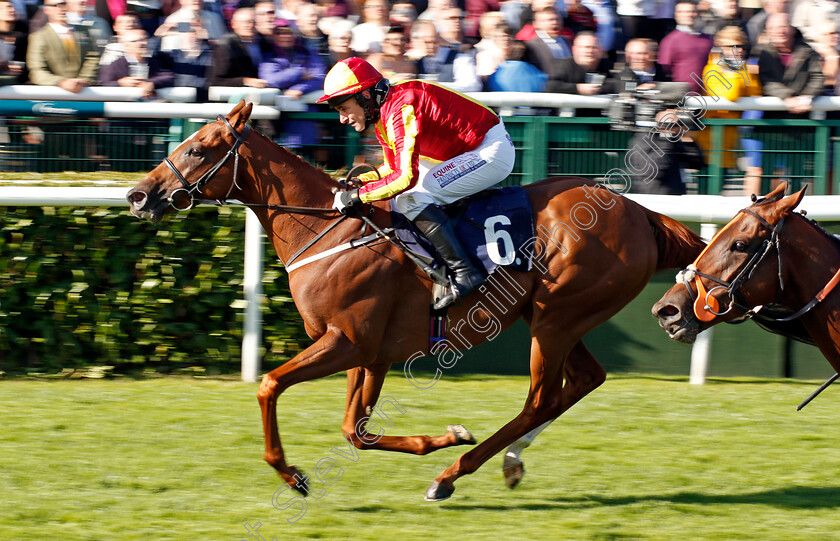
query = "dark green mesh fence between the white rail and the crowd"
xmin=0 ymin=112 xmax=840 ymax=194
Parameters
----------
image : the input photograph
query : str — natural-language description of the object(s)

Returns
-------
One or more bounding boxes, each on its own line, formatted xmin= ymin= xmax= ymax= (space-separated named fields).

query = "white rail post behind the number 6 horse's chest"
xmin=242 ymin=209 xmax=263 ymax=383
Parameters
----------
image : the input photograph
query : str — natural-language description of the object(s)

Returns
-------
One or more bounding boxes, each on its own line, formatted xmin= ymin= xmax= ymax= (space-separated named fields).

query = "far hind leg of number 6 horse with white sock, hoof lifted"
xmin=502 ymin=342 xmax=607 ymax=488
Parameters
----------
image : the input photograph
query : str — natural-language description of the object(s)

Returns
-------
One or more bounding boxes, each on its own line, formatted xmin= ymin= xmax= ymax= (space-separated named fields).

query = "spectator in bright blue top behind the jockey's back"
xmin=482 ymin=22 xmax=548 ymax=91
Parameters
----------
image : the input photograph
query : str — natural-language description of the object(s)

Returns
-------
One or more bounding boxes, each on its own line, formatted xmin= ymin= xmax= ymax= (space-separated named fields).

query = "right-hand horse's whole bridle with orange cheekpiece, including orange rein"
xmin=677 ymin=209 xmax=840 ymax=323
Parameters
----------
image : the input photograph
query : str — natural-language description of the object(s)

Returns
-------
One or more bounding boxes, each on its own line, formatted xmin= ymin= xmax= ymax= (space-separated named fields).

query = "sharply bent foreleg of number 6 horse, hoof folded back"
xmin=341 ymin=364 xmax=475 ymax=455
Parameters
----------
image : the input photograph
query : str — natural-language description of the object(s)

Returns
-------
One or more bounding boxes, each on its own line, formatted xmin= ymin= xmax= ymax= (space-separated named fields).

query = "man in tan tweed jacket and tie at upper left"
xmin=26 ymin=0 xmax=99 ymax=92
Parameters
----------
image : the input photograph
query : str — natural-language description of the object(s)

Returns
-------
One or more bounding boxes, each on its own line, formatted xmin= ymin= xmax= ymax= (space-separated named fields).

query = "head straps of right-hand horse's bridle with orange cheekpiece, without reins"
xmin=677 ymin=209 xmax=788 ymax=322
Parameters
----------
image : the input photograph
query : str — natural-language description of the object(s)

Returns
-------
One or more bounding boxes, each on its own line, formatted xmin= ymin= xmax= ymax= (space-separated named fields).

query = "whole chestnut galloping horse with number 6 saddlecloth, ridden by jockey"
xmin=127 ymin=102 xmax=703 ymax=501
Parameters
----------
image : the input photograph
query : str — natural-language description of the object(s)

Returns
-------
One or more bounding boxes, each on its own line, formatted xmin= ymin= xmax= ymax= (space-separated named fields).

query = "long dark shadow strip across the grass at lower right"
xmin=436 ymin=486 xmax=840 ymax=511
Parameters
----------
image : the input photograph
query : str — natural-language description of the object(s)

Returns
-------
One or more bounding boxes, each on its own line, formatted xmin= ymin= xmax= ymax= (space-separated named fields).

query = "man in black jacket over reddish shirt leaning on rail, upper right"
xmin=756 ymin=13 xmax=825 ymax=114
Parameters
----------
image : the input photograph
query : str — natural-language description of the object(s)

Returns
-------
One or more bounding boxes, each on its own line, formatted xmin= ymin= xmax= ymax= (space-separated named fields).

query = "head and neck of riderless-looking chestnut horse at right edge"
xmin=653 ymin=184 xmax=840 ymax=380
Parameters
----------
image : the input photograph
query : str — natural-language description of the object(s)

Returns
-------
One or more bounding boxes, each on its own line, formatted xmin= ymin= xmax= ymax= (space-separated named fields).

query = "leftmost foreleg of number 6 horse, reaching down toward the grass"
xmin=257 ymin=328 xmax=364 ymax=495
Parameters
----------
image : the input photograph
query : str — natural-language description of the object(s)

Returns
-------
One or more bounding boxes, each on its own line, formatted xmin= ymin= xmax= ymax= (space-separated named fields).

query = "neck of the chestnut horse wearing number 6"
xmin=239 ymin=138 xmax=336 ymax=261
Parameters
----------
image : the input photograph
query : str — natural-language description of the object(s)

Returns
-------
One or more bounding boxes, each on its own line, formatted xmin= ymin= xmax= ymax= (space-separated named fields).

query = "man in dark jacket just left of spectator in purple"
xmin=209 ymin=8 xmax=268 ymax=88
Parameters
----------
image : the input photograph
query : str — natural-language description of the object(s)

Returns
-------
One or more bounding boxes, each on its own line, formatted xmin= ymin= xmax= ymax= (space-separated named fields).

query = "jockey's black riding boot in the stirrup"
xmin=413 ymin=205 xmax=484 ymax=310
